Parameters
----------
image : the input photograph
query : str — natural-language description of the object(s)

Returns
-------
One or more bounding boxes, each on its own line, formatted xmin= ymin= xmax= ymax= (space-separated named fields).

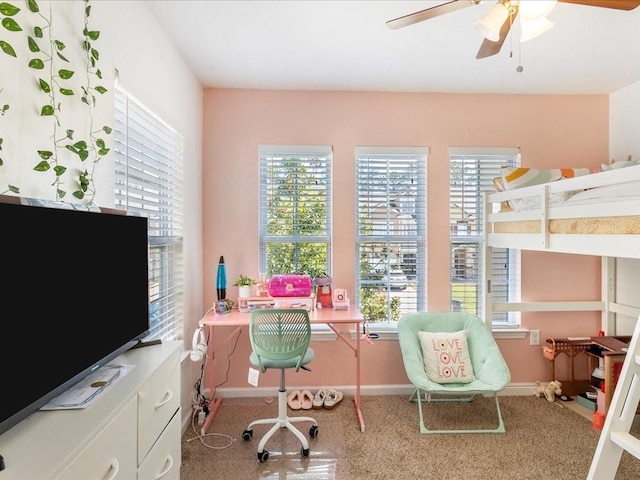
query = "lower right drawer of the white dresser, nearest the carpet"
xmin=138 ymin=409 xmax=182 ymax=480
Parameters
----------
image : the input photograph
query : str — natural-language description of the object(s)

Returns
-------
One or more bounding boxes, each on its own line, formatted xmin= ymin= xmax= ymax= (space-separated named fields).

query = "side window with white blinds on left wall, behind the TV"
xmin=112 ymin=86 xmax=183 ymax=340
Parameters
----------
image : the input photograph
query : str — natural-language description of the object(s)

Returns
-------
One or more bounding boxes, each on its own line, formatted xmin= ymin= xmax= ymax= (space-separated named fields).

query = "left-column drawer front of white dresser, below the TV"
xmin=57 ymin=397 xmax=137 ymax=480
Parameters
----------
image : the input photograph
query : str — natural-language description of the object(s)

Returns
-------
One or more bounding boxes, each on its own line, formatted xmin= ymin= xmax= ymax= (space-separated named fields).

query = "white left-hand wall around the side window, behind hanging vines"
xmin=0 ymin=0 xmax=203 ymax=432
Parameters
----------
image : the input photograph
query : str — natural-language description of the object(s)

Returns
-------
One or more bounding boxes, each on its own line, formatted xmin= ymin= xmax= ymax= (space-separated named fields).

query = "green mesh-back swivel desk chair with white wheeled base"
xmin=242 ymin=308 xmax=318 ymax=462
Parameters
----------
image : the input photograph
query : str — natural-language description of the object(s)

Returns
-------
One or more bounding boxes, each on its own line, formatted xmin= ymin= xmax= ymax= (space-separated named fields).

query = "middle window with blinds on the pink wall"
xmin=355 ymin=147 xmax=428 ymax=330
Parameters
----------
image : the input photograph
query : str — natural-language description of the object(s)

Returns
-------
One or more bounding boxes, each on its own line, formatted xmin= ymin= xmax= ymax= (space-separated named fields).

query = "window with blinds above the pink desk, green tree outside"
xmin=259 ymin=145 xmax=332 ymax=278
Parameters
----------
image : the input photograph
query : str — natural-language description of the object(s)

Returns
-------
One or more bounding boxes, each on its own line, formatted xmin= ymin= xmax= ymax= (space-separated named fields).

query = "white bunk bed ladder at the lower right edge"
xmin=587 ymin=318 xmax=640 ymax=480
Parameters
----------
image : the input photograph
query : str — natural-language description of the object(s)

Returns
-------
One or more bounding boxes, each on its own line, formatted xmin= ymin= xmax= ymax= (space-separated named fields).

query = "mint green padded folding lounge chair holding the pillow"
xmin=398 ymin=312 xmax=511 ymax=433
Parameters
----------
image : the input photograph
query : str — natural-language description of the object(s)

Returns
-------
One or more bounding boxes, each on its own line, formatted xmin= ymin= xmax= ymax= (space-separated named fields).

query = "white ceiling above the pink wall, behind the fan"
xmin=145 ymin=0 xmax=640 ymax=94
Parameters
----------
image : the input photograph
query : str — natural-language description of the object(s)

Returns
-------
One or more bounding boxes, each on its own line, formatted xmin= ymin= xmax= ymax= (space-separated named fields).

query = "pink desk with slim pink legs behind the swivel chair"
xmin=200 ymin=307 xmax=364 ymax=434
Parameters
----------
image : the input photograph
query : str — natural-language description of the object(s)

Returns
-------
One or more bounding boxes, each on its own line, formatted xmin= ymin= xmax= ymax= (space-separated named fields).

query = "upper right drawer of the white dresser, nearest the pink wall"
xmin=138 ymin=352 xmax=180 ymax=465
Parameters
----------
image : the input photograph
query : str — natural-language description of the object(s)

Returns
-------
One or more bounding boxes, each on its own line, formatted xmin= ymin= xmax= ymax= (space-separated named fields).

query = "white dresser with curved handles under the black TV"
xmin=0 ymin=341 xmax=182 ymax=480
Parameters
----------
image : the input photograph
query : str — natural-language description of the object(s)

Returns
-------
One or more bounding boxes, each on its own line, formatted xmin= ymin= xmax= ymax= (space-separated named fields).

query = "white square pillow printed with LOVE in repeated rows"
xmin=418 ymin=330 xmax=475 ymax=383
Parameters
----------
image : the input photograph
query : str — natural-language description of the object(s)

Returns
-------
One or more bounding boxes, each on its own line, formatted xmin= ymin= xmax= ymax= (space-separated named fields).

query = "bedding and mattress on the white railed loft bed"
xmin=488 ymin=161 xmax=640 ymax=235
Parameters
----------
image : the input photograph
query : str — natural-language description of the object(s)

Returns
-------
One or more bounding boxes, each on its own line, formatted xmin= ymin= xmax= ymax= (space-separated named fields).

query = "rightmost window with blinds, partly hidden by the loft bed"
xmin=449 ymin=144 xmax=520 ymax=328
